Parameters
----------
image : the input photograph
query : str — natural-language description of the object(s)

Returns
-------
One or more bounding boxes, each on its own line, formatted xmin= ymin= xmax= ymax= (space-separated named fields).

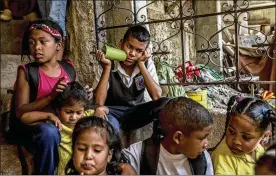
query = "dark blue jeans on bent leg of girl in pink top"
xmin=25 ymin=123 xmax=61 ymax=175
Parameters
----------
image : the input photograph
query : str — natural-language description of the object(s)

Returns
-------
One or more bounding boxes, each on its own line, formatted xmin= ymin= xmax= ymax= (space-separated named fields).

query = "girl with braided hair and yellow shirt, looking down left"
xmin=212 ymin=96 xmax=275 ymax=175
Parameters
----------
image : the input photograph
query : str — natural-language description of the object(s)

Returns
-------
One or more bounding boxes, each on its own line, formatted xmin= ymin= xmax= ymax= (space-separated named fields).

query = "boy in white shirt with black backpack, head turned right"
xmin=124 ymin=97 xmax=213 ymax=175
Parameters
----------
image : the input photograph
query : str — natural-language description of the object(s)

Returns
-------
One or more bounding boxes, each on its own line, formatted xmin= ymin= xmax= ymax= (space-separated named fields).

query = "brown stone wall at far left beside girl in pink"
xmin=0 ymin=20 xmax=28 ymax=112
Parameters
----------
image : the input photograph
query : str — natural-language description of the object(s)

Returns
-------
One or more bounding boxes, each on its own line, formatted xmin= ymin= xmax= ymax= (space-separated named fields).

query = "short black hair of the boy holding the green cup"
xmin=123 ymin=25 xmax=150 ymax=44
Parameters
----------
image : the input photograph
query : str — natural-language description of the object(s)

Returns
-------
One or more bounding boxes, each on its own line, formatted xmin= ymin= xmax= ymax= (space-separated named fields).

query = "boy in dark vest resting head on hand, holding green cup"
xmin=93 ymin=25 xmax=162 ymax=130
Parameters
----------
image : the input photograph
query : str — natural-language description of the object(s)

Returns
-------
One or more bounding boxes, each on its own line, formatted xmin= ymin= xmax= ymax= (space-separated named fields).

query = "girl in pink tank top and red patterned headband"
xmin=15 ymin=20 xmax=76 ymax=175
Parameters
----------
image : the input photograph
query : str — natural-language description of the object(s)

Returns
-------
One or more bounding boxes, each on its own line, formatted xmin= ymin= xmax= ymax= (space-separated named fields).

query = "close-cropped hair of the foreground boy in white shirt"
xmin=160 ymin=97 xmax=213 ymax=135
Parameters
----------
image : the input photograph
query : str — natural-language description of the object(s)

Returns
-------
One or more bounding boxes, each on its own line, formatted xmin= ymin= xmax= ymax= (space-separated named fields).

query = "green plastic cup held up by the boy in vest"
xmin=102 ymin=45 xmax=127 ymax=61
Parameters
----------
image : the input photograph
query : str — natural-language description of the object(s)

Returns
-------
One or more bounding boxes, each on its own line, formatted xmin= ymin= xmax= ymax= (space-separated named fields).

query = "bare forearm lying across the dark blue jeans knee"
xmin=21 ymin=111 xmax=62 ymax=130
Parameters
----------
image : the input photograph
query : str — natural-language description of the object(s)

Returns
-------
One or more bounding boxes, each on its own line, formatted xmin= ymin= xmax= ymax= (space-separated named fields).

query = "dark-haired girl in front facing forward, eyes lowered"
xmin=65 ymin=116 xmax=134 ymax=175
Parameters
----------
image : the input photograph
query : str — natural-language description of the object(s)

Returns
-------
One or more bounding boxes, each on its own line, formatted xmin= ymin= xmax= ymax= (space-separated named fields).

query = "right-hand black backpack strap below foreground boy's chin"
xmin=188 ymin=152 xmax=207 ymax=175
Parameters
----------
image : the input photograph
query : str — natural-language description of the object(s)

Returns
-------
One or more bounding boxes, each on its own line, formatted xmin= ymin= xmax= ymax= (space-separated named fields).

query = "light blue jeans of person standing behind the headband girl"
xmin=37 ymin=0 xmax=67 ymax=36
